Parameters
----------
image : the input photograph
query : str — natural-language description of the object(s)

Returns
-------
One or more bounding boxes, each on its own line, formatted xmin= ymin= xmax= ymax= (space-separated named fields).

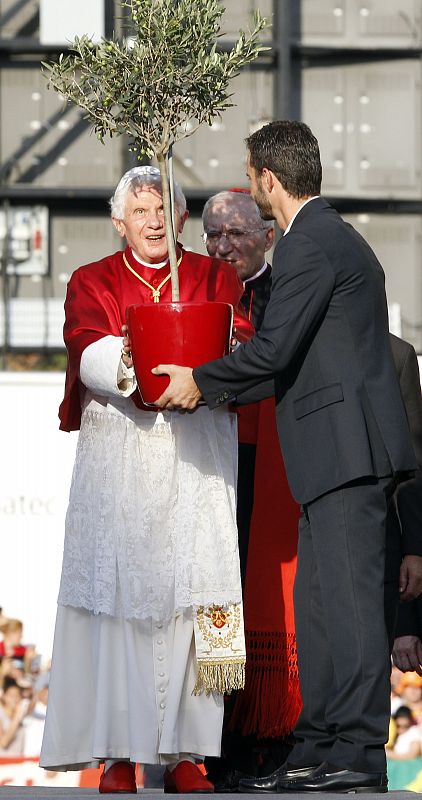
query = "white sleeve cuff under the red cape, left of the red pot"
xmin=79 ymin=336 xmax=136 ymax=397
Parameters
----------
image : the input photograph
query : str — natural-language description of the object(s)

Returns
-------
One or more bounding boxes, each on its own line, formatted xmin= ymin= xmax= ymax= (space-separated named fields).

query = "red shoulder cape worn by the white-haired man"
xmin=59 ymin=247 xmax=253 ymax=431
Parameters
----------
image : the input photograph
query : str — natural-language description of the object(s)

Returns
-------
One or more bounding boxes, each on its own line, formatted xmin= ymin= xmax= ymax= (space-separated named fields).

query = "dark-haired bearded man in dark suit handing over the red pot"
xmin=157 ymin=121 xmax=416 ymax=793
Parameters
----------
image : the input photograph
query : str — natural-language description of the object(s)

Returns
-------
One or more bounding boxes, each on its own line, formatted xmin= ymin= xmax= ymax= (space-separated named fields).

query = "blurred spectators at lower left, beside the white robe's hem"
xmin=0 ymin=609 xmax=50 ymax=759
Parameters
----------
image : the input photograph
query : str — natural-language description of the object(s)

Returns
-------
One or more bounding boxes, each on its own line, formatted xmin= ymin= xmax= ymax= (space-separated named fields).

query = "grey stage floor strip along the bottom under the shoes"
xmin=0 ymin=786 xmax=418 ymax=800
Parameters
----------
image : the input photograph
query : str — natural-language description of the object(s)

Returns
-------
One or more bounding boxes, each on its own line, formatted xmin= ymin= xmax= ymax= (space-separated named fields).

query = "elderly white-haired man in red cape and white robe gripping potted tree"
xmin=40 ymin=166 xmax=249 ymax=793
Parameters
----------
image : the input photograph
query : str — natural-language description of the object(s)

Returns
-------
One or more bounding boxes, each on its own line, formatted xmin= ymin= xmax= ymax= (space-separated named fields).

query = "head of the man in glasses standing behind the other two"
xmin=202 ymin=192 xmax=274 ymax=281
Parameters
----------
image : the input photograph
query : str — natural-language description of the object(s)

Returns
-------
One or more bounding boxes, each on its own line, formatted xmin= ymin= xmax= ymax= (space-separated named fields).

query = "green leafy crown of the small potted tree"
xmin=43 ymin=0 xmax=268 ymax=158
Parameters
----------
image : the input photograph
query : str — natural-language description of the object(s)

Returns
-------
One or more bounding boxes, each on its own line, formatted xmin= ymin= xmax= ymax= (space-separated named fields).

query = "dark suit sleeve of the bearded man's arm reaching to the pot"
xmin=193 ymin=232 xmax=335 ymax=408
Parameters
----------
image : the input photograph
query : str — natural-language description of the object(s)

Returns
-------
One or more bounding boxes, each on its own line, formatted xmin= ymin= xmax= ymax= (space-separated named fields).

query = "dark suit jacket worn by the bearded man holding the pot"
xmin=193 ymin=198 xmax=416 ymax=503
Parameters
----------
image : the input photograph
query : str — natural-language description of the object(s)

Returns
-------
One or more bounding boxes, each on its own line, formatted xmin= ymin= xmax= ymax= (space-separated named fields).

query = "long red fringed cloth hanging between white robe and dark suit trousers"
xmin=230 ymin=398 xmax=301 ymax=738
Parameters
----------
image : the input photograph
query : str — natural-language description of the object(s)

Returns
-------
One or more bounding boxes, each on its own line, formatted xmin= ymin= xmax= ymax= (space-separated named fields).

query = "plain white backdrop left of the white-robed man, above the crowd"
xmin=0 ymin=372 xmax=77 ymax=659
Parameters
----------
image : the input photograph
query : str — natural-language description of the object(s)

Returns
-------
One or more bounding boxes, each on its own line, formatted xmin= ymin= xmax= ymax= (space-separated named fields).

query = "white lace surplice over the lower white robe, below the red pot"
xmin=59 ymin=337 xmax=241 ymax=620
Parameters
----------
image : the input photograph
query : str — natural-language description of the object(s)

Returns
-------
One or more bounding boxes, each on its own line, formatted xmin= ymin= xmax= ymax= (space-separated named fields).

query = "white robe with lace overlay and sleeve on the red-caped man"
xmin=40 ymin=336 xmax=241 ymax=770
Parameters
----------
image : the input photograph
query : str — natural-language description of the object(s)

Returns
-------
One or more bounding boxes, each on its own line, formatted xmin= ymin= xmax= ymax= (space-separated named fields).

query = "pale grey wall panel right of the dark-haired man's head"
xmin=302 ymin=60 xmax=422 ymax=199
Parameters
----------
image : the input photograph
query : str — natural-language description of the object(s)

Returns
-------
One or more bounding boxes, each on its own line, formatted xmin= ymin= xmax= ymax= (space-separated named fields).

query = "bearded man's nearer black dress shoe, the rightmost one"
xmin=278 ymin=761 xmax=388 ymax=794
